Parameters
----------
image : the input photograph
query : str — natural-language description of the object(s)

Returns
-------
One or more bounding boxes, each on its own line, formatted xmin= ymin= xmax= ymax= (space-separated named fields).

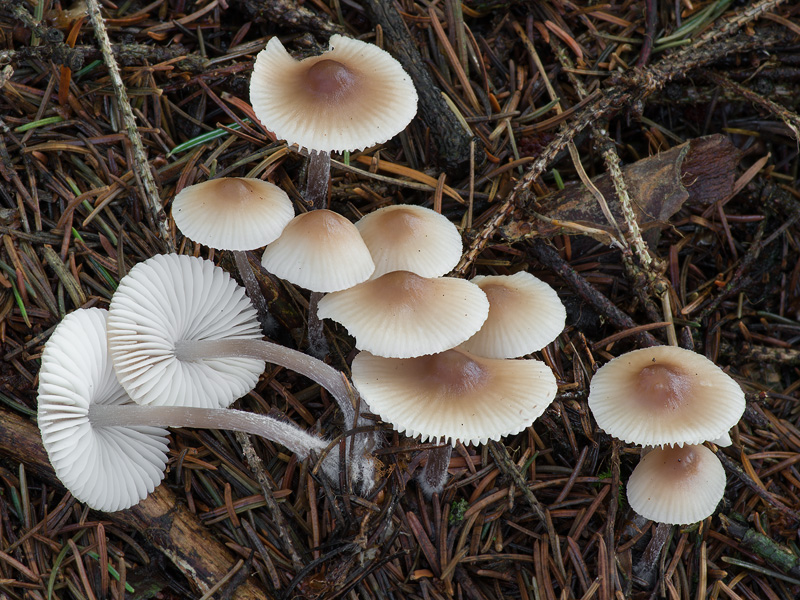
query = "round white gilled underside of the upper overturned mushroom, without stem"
xmin=108 ymin=254 xmax=264 ymax=408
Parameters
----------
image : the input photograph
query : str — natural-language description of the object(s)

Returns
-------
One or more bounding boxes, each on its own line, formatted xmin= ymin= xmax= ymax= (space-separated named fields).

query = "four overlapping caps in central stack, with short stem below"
xmin=312 ymin=205 xmax=566 ymax=493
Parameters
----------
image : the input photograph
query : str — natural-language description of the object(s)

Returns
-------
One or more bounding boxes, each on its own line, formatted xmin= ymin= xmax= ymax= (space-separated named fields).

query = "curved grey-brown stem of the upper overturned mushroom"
xmin=175 ymin=339 xmax=355 ymax=427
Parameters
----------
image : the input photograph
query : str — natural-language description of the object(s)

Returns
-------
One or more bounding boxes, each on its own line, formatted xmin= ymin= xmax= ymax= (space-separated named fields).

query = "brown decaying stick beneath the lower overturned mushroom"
xmin=0 ymin=409 xmax=270 ymax=600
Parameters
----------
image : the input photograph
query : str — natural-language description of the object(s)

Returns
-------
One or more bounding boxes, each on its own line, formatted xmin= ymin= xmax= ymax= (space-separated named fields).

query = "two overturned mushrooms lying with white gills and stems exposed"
xmin=38 ymin=254 xmax=349 ymax=511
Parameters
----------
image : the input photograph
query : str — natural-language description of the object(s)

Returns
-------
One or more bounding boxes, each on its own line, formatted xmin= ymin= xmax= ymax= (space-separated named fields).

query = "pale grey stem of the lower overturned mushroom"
xmin=89 ymin=404 xmax=339 ymax=481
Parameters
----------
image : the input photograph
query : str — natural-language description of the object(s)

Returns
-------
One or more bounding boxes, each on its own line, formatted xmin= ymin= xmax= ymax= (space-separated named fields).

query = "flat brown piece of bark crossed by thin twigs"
xmin=499 ymin=135 xmax=739 ymax=242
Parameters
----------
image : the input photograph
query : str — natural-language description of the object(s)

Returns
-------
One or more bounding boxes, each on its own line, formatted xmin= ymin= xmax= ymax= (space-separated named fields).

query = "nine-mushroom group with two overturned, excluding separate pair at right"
xmin=39 ymin=31 xmax=565 ymax=511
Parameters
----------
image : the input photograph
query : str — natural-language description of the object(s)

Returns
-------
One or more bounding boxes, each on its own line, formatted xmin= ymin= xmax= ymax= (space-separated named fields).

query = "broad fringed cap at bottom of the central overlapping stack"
xmin=353 ymin=349 xmax=558 ymax=445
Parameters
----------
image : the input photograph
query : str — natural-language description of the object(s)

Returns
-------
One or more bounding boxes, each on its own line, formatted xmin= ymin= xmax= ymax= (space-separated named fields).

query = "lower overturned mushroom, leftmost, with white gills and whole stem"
xmin=38 ymin=308 xmax=338 ymax=512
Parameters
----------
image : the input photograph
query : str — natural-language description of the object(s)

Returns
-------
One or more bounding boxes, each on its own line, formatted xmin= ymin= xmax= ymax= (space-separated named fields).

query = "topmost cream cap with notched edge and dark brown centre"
xmin=250 ymin=35 xmax=417 ymax=152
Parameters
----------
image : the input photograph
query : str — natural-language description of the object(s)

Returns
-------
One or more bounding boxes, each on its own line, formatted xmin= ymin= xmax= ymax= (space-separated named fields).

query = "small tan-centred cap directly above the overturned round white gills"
xmin=172 ymin=177 xmax=294 ymax=251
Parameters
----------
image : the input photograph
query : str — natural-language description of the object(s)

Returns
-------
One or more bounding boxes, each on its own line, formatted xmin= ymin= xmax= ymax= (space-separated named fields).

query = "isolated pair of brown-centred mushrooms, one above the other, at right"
xmin=589 ymin=346 xmax=745 ymax=524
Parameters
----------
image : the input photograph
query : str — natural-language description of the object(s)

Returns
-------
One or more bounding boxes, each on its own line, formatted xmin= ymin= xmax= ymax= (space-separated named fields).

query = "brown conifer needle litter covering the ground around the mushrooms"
xmin=0 ymin=0 xmax=800 ymax=600
